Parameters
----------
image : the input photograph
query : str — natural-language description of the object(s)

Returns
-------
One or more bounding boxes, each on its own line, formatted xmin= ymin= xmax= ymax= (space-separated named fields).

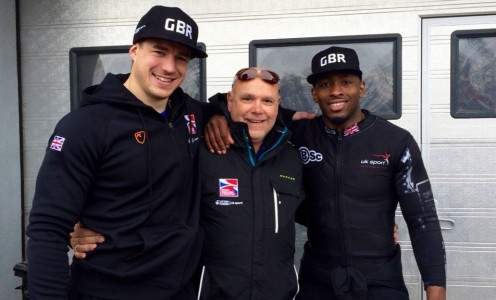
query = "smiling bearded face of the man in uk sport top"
xmin=312 ymin=73 xmax=365 ymax=130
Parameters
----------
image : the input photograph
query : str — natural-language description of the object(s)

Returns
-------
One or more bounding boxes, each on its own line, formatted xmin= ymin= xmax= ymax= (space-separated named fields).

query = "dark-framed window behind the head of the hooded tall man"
xmin=69 ymin=43 xmax=206 ymax=109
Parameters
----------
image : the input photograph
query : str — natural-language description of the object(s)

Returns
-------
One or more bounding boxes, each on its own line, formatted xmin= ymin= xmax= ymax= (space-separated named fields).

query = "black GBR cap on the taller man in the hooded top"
xmin=133 ymin=5 xmax=208 ymax=58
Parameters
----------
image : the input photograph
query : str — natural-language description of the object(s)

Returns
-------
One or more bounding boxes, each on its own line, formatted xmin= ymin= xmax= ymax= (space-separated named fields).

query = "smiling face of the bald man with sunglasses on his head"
xmin=227 ymin=72 xmax=281 ymax=152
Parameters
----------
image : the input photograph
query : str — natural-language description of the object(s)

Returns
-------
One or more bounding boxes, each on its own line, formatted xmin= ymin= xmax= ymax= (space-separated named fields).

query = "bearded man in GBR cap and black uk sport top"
xmin=292 ymin=47 xmax=446 ymax=300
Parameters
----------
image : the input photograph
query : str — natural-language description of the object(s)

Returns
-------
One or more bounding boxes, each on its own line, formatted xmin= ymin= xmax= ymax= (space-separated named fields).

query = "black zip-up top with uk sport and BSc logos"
xmin=291 ymin=110 xmax=446 ymax=292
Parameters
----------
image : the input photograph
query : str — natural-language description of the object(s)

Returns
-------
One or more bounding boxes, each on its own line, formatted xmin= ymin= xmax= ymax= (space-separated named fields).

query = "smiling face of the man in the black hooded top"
xmin=124 ymin=39 xmax=191 ymax=112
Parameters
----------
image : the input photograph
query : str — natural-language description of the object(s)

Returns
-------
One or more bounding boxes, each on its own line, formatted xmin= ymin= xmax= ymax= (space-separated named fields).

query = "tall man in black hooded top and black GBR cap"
xmin=27 ymin=6 xmax=212 ymax=300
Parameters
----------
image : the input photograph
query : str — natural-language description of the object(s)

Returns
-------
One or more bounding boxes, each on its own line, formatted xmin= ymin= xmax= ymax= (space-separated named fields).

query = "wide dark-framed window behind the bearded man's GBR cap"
xmin=249 ymin=34 xmax=401 ymax=119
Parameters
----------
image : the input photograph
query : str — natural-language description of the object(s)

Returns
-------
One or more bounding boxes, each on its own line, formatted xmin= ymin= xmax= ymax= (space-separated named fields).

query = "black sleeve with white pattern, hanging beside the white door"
xmin=395 ymin=136 xmax=446 ymax=288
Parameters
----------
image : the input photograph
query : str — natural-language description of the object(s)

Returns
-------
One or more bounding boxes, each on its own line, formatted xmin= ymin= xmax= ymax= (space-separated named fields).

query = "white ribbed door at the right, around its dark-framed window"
xmin=420 ymin=15 xmax=496 ymax=300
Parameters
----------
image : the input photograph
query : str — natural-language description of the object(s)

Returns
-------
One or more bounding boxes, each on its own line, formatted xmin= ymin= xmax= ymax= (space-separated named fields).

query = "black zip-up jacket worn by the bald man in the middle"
xmin=199 ymin=94 xmax=303 ymax=300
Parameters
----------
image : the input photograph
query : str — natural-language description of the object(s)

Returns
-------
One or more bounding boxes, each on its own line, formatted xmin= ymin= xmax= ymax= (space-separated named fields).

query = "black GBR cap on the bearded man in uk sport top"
xmin=307 ymin=46 xmax=362 ymax=85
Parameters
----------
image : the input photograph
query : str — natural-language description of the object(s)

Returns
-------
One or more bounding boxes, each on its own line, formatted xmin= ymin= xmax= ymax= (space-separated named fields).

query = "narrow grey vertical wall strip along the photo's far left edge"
xmin=0 ymin=0 xmax=22 ymax=300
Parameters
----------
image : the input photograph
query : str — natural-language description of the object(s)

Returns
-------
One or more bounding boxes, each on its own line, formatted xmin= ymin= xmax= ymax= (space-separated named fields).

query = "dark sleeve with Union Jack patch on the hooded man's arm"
xmin=27 ymin=112 xmax=102 ymax=300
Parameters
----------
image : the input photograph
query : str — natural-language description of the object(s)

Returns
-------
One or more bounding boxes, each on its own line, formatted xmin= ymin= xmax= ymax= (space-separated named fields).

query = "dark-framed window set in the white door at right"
xmin=451 ymin=29 xmax=496 ymax=118
